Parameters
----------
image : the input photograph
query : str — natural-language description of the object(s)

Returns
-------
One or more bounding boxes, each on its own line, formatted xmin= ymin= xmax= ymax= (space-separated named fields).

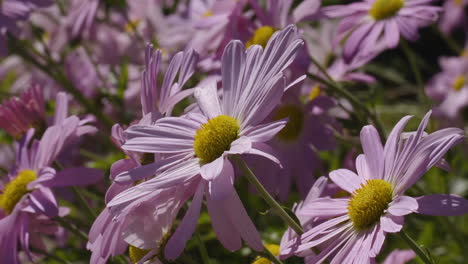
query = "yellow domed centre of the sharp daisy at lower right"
xmin=348 ymin=179 xmax=393 ymax=230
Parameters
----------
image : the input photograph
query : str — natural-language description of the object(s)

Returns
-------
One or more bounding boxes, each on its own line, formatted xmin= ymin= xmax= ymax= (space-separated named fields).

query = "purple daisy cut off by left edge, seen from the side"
xmin=0 ymin=93 xmax=103 ymax=264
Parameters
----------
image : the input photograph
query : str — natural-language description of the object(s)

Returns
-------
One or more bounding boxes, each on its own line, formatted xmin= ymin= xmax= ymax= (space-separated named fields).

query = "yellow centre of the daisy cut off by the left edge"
xmin=0 ymin=170 xmax=37 ymax=214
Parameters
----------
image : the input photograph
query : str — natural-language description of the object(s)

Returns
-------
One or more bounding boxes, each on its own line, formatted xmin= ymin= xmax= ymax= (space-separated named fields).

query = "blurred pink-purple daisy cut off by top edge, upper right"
xmin=323 ymin=0 xmax=441 ymax=62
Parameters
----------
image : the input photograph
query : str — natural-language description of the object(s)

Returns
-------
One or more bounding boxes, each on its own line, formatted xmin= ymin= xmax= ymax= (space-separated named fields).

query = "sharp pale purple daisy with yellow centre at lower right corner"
xmin=281 ymin=112 xmax=468 ymax=263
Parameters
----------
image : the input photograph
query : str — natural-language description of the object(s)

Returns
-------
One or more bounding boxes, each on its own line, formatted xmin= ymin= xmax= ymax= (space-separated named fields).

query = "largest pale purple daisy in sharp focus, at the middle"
xmin=108 ymin=25 xmax=302 ymax=259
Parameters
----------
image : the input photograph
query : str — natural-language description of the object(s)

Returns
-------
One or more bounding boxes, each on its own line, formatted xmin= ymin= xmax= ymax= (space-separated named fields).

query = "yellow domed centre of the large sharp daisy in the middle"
xmin=193 ymin=115 xmax=240 ymax=164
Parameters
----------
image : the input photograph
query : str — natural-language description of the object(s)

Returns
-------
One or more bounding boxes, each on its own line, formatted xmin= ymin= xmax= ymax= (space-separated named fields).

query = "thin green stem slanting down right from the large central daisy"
xmin=231 ymin=155 xmax=304 ymax=235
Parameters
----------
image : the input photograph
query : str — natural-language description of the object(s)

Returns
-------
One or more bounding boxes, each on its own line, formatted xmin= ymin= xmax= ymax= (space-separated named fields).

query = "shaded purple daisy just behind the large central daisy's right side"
xmin=248 ymin=95 xmax=336 ymax=201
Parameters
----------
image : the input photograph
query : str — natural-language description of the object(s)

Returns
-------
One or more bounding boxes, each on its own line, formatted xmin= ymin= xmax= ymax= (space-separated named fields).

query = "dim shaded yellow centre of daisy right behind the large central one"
xmin=273 ymin=105 xmax=304 ymax=141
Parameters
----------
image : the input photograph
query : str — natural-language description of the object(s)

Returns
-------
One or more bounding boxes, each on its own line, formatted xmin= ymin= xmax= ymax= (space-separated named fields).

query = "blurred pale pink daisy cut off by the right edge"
xmin=426 ymin=57 xmax=468 ymax=120
